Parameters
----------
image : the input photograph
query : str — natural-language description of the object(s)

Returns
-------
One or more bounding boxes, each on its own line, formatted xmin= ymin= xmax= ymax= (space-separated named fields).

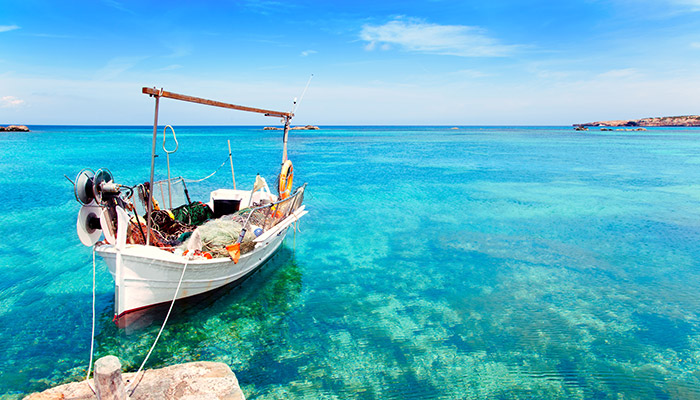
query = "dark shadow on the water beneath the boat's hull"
xmin=114 ymin=245 xmax=301 ymax=335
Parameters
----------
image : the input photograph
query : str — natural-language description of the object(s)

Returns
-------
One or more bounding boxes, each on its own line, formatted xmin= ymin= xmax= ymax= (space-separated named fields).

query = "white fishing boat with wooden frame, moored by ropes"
xmin=74 ymin=88 xmax=307 ymax=319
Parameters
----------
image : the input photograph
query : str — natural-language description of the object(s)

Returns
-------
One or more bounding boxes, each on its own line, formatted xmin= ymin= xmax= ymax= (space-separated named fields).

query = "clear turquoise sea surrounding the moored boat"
xmin=0 ymin=126 xmax=700 ymax=399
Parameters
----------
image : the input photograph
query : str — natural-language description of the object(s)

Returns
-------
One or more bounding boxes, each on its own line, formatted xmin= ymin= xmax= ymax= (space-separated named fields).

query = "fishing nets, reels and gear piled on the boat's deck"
xmin=75 ymin=160 xmax=305 ymax=259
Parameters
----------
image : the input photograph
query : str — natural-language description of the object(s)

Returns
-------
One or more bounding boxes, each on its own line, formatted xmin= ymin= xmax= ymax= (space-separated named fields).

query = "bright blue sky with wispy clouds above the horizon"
xmin=0 ymin=0 xmax=700 ymax=125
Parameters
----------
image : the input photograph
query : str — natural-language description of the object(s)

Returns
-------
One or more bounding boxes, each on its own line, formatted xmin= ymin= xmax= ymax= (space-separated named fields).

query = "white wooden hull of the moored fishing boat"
xmin=96 ymin=227 xmax=287 ymax=318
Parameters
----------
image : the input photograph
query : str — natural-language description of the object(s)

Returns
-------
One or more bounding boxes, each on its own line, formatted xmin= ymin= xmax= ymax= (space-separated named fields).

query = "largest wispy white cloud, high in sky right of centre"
xmin=360 ymin=18 xmax=517 ymax=57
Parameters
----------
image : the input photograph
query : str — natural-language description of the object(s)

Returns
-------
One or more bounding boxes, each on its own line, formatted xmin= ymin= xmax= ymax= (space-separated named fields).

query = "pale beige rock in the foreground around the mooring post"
xmin=25 ymin=362 xmax=245 ymax=400
